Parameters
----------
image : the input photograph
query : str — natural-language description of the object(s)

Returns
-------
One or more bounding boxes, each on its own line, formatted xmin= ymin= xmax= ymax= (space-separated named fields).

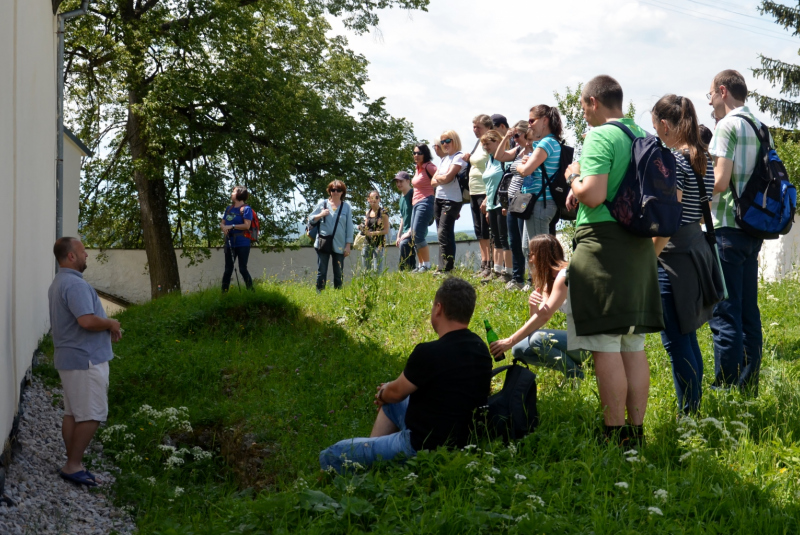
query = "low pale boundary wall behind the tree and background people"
xmin=83 ymin=241 xmax=480 ymax=303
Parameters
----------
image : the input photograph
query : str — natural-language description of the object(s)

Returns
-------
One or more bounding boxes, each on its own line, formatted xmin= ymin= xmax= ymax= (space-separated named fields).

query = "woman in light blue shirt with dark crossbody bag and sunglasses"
xmin=308 ymin=180 xmax=353 ymax=293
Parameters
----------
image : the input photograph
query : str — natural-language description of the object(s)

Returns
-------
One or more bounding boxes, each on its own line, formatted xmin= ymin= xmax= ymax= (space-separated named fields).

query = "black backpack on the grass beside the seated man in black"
xmin=486 ymin=359 xmax=539 ymax=440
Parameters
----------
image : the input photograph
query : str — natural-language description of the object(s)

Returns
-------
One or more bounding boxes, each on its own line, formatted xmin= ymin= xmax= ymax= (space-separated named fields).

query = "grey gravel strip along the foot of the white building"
xmin=0 ymin=377 xmax=135 ymax=535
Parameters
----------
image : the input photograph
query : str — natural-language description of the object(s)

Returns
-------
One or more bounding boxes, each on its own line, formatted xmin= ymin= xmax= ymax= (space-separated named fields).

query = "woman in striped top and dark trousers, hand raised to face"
xmin=494 ymin=121 xmax=533 ymax=290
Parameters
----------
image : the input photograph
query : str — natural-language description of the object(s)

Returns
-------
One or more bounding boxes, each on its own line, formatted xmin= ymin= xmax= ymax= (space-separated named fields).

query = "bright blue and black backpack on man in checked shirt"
xmin=730 ymin=115 xmax=797 ymax=240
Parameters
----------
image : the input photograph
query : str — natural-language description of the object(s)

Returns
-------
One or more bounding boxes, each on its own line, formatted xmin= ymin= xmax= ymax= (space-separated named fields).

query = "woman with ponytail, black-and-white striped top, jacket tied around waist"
xmin=652 ymin=95 xmax=716 ymax=414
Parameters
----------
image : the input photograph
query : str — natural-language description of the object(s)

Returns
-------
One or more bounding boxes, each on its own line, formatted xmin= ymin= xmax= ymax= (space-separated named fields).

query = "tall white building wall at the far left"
xmin=0 ymin=0 xmax=56 ymax=448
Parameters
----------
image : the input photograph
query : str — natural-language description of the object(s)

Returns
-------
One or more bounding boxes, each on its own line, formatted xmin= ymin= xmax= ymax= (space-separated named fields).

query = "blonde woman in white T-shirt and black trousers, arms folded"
xmin=431 ymin=130 xmax=467 ymax=275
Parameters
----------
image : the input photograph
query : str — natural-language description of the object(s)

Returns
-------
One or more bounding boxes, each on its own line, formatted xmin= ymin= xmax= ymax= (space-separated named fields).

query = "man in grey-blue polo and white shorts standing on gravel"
xmin=47 ymin=237 xmax=122 ymax=487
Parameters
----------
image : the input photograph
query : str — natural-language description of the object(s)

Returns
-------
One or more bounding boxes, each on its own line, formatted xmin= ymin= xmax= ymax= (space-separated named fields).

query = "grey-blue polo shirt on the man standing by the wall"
xmin=47 ymin=268 xmax=114 ymax=370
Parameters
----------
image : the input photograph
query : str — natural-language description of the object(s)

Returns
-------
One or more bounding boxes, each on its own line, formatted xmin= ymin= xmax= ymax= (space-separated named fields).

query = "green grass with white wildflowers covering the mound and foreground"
xmin=39 ymin=274 xmax=800 ymax=534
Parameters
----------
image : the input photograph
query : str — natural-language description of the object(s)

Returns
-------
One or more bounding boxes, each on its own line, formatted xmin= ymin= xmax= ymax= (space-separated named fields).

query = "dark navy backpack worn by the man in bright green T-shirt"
xmin=605 ymin=121 xmax=683 ymax=238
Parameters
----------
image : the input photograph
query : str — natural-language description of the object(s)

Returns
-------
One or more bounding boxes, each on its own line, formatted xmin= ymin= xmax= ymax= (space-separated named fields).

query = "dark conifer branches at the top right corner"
xmin=752 ymin=0 xmax=800 ymax=127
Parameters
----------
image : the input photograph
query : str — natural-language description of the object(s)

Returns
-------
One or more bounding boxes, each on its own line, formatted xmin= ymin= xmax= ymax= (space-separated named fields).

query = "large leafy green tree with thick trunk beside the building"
xmin=61 ymin=0 xmax=428 ymax=297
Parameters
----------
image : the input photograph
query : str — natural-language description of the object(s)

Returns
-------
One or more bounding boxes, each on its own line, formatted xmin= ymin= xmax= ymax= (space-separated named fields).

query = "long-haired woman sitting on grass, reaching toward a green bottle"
xmin=490 ymin=234 xmax=583 ymax=379
